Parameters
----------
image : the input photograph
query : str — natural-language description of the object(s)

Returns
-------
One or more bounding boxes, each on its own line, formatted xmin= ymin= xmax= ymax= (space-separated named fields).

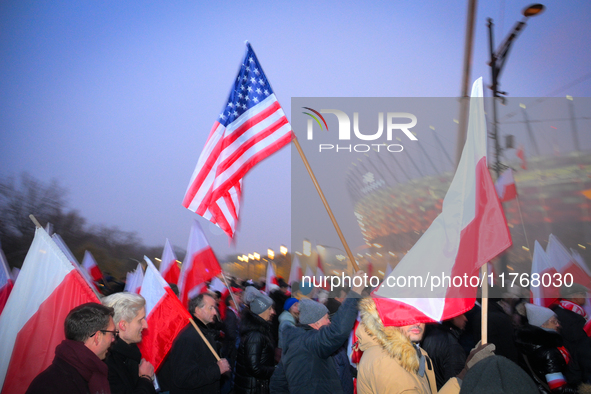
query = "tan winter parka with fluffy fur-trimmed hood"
xmin=355 ymin=298 xmax=460 ymax=394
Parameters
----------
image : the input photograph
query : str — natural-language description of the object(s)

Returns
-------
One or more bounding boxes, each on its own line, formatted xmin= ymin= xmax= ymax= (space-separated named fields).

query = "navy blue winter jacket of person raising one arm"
xmin=271 ymin=291 xmax=360 ymax=394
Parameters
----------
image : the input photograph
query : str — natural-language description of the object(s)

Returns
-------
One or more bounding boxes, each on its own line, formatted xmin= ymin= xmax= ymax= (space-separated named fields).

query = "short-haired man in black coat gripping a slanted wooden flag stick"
xmin=168 ymin=294 xmax=230 ymax=394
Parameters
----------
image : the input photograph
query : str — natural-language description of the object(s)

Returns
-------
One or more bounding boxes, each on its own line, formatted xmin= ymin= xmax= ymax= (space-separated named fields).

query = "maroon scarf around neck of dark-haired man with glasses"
xmin=55 ymin=339 xmax=111 ymax=394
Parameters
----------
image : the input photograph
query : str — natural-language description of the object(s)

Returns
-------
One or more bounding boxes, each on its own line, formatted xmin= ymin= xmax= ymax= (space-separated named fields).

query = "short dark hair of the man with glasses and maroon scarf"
xmin=64 ymin=302 xmax=115 ymax=342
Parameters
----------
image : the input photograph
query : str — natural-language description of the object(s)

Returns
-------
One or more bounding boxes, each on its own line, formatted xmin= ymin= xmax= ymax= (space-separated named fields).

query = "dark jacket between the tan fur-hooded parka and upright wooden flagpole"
xmin=421 ymin=324 xmax=466 ymax=390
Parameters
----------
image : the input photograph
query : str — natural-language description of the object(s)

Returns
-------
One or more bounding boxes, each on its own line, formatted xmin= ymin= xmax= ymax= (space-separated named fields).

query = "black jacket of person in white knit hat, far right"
xmin=517 ymin=324 xmax=577 ymax=393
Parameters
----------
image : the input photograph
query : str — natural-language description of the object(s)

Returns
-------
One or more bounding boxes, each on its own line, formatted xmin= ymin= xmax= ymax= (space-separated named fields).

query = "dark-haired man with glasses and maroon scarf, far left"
xmin=27 ymin=302 xmax=117 ymax=394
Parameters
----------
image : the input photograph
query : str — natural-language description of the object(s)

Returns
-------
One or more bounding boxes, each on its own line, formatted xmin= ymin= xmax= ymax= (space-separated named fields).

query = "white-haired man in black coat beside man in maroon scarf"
xmin=102 ymin=293 xmax=156 ymax=394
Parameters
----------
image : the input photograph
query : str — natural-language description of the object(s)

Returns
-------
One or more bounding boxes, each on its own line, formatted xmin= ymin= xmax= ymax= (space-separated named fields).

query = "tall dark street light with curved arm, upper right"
xmin=488 ymin=4 xmax=545 ymax=178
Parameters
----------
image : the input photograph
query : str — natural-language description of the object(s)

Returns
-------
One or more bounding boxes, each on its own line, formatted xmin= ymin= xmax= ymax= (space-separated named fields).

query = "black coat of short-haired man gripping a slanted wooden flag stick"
xmin=167 ymin=318 xmax=221 ymax=394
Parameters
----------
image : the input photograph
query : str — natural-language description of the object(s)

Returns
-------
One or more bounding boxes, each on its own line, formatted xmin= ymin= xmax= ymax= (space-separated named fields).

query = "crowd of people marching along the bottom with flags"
xmin=27 ymin=271 xmax=591 ymax=394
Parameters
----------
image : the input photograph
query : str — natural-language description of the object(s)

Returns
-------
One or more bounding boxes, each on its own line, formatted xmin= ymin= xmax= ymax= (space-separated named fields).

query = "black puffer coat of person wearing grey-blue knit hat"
xmin=234 ymin=309 xmax=275 ymax=394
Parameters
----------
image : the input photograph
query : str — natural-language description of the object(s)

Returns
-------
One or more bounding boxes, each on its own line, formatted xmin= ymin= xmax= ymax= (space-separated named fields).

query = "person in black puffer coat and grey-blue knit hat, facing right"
xmin=234 ymin=287 xmax=275 ymax=394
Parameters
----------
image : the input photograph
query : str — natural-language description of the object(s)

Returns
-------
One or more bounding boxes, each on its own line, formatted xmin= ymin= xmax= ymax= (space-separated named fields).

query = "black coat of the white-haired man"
xmin=105 ymin=338 xmax=156 ymax=394
